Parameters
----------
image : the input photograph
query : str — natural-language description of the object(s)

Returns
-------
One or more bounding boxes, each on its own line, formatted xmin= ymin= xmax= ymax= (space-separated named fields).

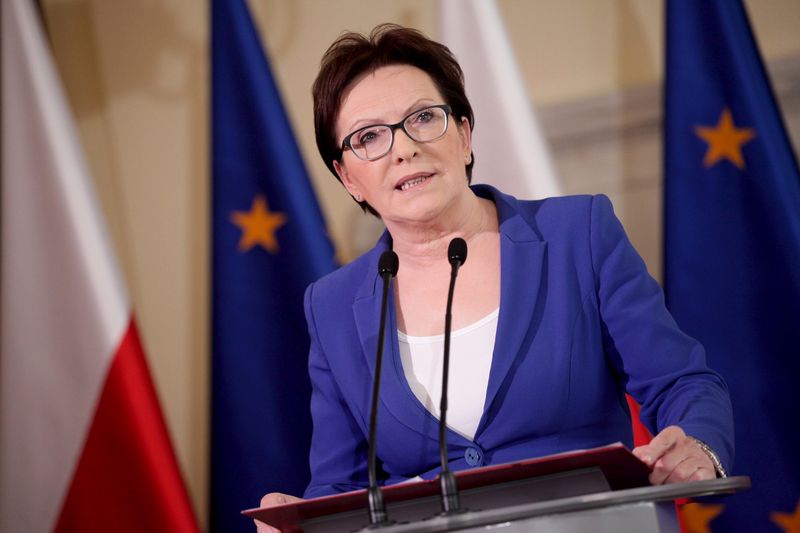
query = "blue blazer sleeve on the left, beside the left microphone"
xmin=304 ymin=283 xmax=369 ymax=498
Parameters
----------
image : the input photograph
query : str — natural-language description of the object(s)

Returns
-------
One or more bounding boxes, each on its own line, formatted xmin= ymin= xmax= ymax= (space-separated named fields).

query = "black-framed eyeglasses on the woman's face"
xmin=342 ymin=104 xmax=451 ymax=161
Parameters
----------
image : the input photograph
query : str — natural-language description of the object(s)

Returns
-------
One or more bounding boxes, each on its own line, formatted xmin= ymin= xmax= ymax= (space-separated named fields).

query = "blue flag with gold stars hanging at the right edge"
xmin=664 ymin=0 xmax=800 ymax=532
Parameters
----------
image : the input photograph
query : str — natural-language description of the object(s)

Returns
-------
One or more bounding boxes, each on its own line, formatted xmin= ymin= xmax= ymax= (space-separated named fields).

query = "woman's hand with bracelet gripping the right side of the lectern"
xmin=633 ymin=426 xmax=717 ymax=485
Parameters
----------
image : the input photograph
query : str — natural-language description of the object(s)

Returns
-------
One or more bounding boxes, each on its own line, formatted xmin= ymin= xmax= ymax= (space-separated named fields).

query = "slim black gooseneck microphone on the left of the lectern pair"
xmin=366 ymin=250 xmax=400 ymax=529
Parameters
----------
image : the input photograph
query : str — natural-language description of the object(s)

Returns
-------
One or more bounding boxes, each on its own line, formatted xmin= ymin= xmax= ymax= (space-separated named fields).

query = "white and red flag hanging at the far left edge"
xmin=0 ymin=0 xmax=199 ymax=533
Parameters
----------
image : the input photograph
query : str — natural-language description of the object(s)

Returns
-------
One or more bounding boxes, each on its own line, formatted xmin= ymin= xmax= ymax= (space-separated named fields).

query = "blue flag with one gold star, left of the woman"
xmin=210 ymin=0 xmax=335 ymax=533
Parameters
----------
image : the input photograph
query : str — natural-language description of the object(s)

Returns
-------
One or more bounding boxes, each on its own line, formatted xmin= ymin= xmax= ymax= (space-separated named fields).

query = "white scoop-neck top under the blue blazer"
xmin=397 ymin=308 xmax=500 ymax=440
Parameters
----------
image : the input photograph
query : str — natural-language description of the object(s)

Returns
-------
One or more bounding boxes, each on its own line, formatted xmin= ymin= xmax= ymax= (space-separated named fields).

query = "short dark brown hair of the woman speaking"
xmin=311 ymin=24 xmax=475 ymax=216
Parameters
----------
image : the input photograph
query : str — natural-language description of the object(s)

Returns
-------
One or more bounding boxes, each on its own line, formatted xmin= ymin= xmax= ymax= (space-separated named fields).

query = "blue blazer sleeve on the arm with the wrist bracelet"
xmin=590 ymin=195 xmax=733 ymax=471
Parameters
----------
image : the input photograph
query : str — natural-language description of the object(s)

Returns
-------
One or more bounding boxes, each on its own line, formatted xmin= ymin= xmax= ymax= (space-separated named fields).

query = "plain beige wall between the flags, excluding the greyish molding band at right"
xmin=43 ymin=0 xmax=800 ymax=520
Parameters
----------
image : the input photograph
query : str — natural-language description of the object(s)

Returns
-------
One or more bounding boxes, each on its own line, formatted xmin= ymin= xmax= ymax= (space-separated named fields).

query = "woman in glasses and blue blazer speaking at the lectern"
xmin=262 ymin=21 xmax=732 ymax=528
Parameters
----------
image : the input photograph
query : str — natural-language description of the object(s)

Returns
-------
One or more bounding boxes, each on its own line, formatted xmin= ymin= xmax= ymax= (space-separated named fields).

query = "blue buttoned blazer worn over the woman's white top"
xmin=305 ymin=186 xmax=733 ymax=497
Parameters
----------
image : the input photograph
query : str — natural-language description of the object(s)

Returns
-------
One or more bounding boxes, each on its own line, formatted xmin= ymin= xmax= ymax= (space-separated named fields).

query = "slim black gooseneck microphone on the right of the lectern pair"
xmin=439 ymin=237 xmax=467 ymax=515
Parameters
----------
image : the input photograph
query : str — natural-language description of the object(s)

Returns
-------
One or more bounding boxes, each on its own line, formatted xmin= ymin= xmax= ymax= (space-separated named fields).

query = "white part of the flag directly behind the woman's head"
xmin=439 ymin=0 xmax=562 ymax=200
